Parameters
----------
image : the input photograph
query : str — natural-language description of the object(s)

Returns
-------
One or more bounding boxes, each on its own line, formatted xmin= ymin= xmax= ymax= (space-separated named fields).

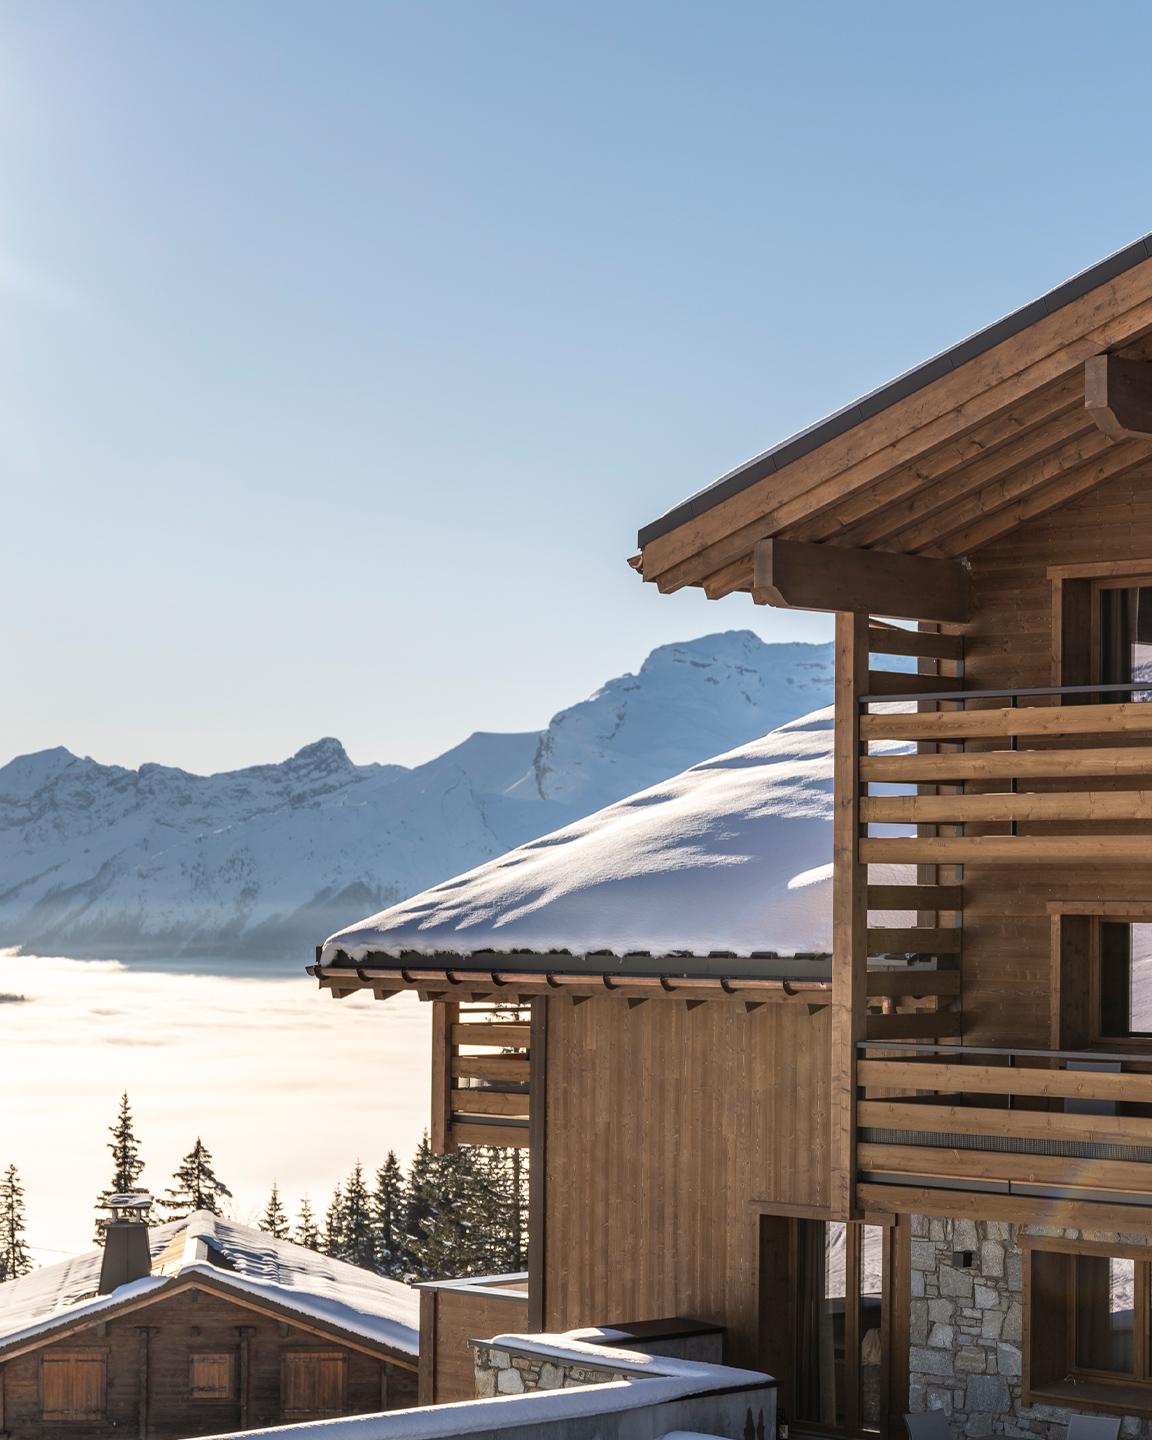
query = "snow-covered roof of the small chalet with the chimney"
xmin=0 ymin=1210 xmax=420 ymax=1356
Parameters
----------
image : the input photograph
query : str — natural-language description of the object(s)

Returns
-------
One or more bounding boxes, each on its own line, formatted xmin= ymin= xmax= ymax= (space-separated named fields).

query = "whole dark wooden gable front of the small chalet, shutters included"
xmin=0 ymin=1284 xmax=416 ymax=1440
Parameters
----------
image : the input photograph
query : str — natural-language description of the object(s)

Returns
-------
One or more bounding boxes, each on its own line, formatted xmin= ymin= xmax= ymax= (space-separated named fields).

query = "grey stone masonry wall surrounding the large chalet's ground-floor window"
xmin=909 ymin=1215 xmax=1152 ymax=1440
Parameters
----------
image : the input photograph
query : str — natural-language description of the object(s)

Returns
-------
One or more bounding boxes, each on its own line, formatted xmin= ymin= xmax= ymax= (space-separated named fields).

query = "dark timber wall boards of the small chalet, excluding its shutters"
xmin=0 ymin=1290 xmax=416 ymax=1440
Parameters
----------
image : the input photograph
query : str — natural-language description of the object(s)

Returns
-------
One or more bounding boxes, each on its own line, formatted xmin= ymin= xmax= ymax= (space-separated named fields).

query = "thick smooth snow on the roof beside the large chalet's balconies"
xmin=321 ymin=708 xmax=858 ymax=975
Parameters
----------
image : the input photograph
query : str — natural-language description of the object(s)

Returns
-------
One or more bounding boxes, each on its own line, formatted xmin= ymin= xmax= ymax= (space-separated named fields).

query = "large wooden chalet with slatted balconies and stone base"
xmin=315 ymin=239 xmax=1152 ymax=1440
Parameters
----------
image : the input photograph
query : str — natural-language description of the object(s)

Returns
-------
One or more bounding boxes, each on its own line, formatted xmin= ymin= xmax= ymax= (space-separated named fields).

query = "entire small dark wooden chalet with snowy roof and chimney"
xmin=0 ymin=1211 xmax=419 ymax=1440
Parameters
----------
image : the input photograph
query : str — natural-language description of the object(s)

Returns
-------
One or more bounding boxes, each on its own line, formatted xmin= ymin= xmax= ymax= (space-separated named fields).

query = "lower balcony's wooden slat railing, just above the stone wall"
xmin=855 ymin=1041 xmax=1152 ymax=1207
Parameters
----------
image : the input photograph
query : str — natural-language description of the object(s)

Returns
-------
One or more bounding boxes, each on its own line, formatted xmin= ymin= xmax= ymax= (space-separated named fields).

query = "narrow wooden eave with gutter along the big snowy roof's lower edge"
xmin=308 ymin=956 xmax=832 ymax=1005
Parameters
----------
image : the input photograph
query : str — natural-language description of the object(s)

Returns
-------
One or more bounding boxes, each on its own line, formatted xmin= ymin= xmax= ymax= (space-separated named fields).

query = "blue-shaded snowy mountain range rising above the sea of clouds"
xmin=0 ymin=631 xmax=832 ymax=963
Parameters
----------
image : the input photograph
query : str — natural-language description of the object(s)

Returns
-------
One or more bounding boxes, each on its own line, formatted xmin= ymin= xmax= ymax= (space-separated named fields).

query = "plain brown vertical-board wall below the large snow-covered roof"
xmin=544 ymin=998 xmax=829 ymax=1365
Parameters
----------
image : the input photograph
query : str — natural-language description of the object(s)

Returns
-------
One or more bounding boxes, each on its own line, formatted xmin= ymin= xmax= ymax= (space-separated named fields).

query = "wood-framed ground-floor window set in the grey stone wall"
xmin=1025 ymin=1240 xmax=1152 ymax=1405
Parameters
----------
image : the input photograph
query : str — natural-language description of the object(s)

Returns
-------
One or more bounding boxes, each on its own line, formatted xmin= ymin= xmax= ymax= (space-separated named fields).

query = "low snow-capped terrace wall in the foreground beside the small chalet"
xmin=200 ymin=1332 xmax=776 ymax=1440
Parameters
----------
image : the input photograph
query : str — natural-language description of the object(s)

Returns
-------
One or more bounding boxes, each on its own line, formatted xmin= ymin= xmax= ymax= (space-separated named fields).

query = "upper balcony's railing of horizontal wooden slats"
xmin=858 ymin=675 xmax=1152 ymax=864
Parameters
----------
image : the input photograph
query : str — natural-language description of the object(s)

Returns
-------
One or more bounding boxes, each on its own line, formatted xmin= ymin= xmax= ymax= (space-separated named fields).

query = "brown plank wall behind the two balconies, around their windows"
xmin=963 ymin=472 xmax=1152 ymax=1048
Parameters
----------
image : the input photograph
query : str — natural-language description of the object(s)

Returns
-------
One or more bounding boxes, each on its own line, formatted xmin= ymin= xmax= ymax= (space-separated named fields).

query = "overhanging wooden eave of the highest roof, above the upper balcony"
xmin=631 ymin=238 xmax=1152 ymax=603
